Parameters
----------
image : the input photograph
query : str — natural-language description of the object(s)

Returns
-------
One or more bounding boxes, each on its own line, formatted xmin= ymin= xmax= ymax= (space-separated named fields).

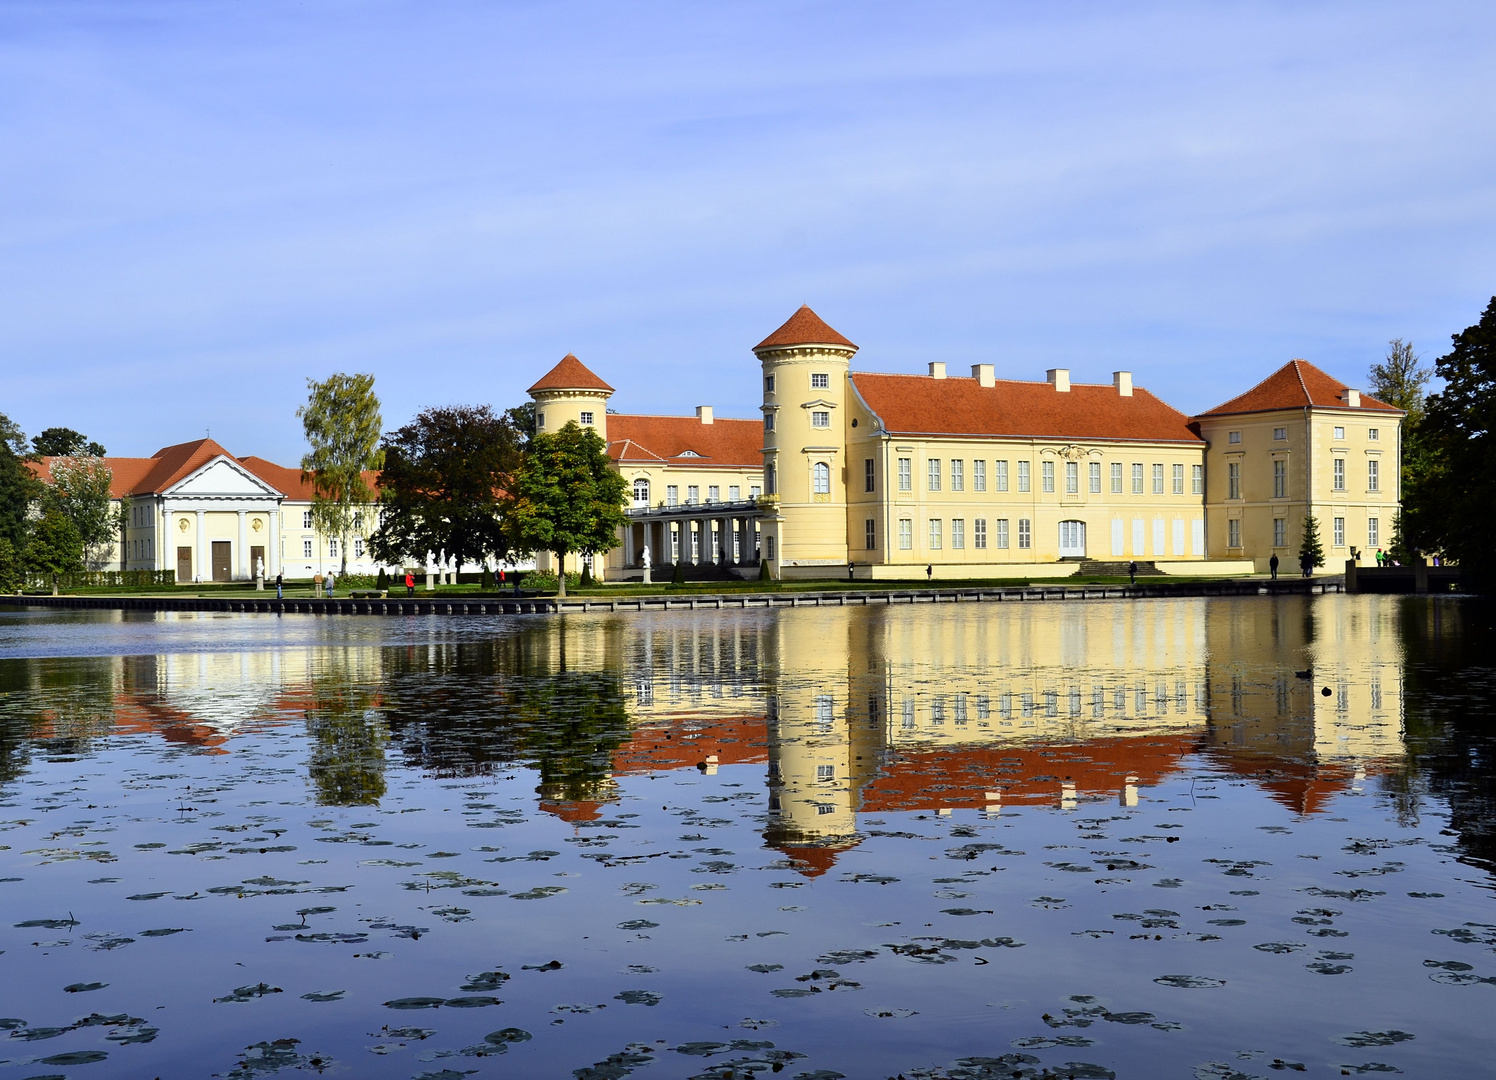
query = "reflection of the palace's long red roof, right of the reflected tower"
xmin=860 ymin=733 xmax=1198 ymax=812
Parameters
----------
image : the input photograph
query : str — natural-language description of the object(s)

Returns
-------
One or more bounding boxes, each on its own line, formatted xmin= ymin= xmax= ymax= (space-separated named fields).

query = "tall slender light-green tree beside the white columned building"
xmin=296 ymin=371 xmax=384 ymax=573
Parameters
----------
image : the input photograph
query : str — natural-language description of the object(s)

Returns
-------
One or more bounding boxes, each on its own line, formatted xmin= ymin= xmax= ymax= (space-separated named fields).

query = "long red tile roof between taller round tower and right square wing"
xmin=851 ymin=372 xmax=1203 ymax=443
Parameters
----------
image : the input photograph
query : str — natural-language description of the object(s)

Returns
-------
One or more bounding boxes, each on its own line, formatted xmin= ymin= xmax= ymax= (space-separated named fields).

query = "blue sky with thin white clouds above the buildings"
xmin=0 ymin=0 xmax=1496 ymax=464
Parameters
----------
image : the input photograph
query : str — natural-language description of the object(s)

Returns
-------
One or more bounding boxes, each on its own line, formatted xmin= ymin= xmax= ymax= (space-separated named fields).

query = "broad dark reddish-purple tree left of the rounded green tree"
xmin=370 ymin=405 xmax=521 ymax=571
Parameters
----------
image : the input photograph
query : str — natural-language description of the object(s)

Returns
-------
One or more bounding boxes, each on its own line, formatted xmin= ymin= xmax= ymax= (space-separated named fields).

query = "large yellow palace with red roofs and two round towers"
xmin=530 ymin=307 xmax=1402 ymax=579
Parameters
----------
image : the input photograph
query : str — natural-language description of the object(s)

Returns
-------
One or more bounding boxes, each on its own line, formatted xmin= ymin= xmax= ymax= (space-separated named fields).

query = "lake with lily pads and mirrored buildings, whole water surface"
xmin=0 ymin=595 xmax=1496 ymax=1080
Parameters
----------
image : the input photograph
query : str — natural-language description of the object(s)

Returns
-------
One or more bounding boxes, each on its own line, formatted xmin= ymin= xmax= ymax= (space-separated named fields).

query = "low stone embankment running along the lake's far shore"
xmin=0 ymin=574 xmax=1345 ymax=615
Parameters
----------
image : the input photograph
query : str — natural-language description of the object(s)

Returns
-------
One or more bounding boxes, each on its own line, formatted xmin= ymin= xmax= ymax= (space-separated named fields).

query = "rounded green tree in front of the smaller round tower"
xmin=506 ymin=420 xmax=628 ymax=597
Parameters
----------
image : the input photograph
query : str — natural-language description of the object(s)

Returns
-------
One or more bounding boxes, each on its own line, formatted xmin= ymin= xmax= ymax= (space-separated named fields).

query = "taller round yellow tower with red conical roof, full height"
xmin=754 ymin=305 xmax=857 ymax=579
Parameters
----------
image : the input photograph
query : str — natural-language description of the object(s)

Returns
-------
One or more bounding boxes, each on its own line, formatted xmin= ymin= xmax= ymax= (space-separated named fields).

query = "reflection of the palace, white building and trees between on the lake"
xmin=4 ymin=597 xmax=1403 ymax=868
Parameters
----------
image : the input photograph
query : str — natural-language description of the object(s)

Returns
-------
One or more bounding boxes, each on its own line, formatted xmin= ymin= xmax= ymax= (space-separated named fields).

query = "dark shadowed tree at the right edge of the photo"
xmin=1420 ymin=296 xmax=1496 ymax=592
